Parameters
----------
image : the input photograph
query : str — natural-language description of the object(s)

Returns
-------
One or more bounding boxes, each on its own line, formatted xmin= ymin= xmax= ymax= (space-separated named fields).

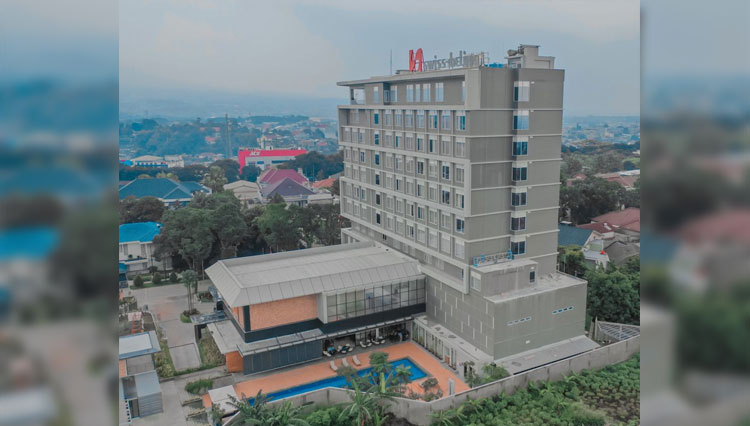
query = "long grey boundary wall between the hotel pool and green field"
xmin=225 ymin=336 xmax=641 ymax=426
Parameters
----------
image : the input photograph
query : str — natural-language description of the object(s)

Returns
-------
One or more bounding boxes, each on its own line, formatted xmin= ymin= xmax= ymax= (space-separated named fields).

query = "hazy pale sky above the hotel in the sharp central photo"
xmin=119 ymin=0 xmax=640 ymax=115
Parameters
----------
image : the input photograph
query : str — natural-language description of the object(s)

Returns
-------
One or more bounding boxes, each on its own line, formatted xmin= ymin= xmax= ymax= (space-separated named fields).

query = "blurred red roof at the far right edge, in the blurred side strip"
xmin=678 ymin=209 xmax=750 ymax=243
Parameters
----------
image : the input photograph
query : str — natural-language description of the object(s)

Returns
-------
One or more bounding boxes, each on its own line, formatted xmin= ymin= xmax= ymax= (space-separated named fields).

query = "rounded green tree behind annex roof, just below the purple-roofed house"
xmin=253 ymin=204 xmax=301 ymax=251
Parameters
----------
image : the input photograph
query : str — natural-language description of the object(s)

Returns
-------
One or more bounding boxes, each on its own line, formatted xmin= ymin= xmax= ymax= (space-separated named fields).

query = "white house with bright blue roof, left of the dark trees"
xmin=119 ymin=222 xmax=172 ymax=276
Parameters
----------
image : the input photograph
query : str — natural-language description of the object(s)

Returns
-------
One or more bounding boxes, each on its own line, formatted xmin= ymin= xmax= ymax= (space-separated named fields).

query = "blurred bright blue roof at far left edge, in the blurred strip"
xmin=0 ymin=228 xmax=60 ymax=260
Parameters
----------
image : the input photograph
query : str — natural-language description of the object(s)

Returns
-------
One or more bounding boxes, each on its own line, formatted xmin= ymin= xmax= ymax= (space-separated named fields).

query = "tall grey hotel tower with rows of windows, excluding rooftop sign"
xmin=338 ymin=45 xmax=593 ymax=371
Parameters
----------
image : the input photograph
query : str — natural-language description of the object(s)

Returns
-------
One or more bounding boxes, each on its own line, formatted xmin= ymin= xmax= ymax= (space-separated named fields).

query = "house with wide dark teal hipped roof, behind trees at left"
xmin=119 ymin=178 xmax=211 ymax=207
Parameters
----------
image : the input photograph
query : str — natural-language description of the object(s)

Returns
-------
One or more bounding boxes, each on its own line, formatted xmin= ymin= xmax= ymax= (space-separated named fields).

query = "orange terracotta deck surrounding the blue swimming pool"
xmin=203 ymin=342 xmax=469 ymax=407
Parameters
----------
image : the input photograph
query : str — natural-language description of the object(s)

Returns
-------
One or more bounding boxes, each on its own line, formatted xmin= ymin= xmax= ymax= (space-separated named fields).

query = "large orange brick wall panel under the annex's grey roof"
xmin=250 ymin=294 xmax=318 ymax=330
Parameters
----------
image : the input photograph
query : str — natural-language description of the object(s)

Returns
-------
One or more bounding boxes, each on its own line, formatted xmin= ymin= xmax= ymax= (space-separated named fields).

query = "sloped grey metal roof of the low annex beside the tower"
xmin=206 ymin=241 xmax=423 ymax=307
